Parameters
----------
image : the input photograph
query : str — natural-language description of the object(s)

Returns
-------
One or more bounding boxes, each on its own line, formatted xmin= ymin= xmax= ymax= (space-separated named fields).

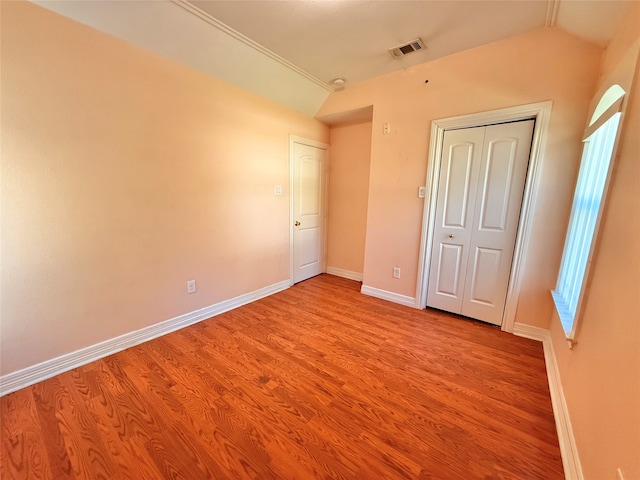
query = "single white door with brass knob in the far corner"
xmin=292 ymin=142 xmax=326 ymax=283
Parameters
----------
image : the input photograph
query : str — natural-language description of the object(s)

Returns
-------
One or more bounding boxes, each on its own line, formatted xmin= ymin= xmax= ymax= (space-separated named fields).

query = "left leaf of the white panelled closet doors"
xmin=427 ymin=129 xmax=484 ymax=312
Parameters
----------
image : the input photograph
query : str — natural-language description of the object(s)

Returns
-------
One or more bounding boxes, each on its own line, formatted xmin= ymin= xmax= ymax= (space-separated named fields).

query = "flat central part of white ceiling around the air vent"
xmin=191 ymin=0 xmax=547 ymax=83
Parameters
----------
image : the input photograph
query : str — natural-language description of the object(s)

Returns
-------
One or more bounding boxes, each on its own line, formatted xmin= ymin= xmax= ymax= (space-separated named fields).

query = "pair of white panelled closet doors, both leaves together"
xmin=427 ymin=120 xmax=534 ymax=325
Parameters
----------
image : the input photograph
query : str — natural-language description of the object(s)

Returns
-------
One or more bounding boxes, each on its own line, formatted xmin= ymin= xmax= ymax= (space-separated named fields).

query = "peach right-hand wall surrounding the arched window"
xmin=551 ymin=4 xmax=640 ymax=480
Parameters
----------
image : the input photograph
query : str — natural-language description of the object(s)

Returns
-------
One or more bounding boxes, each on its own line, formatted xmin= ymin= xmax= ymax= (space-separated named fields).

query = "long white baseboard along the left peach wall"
xmin=0 ymin=280 xmax=289 ymax=397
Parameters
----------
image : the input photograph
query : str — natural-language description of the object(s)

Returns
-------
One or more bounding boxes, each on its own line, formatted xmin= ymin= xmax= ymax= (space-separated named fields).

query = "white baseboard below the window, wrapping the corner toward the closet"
xmin=513 ymin=323 xmax=584 ymax=480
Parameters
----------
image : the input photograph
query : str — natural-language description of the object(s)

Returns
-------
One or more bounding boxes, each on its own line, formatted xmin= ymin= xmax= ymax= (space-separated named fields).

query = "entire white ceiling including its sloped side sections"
xmin=28 ymin=0 xmax=638 ymax=115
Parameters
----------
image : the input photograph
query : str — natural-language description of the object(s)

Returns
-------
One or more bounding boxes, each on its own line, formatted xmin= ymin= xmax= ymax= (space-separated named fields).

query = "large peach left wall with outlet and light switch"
xmin=0 ymin=2 xmax=329 ymax=374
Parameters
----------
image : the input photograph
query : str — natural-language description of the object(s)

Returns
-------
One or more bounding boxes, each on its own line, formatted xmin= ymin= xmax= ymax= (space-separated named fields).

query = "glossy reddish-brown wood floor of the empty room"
xmin=0 ymin=275 xmax=564 ymax=480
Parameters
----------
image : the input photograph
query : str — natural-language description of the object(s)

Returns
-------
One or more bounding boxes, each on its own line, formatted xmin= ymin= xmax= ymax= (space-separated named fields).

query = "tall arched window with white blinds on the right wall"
xmin=551 ymin=85 xmax=625 ymax=344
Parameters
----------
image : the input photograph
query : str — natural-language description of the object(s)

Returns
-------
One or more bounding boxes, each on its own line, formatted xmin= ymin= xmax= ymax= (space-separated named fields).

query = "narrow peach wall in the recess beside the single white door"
xmin=327 ymin=122 xmax=371 ymax=274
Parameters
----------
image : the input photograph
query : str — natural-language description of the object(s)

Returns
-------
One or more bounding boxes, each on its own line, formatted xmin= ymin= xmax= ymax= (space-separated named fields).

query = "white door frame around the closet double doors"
xmin=416 ymin=101 xmax=552 ymax=333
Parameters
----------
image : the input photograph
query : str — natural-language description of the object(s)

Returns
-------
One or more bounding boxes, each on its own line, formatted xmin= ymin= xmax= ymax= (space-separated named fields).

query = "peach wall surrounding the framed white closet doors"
xmin=318 ymin=30 xmax=601 ymax=328
